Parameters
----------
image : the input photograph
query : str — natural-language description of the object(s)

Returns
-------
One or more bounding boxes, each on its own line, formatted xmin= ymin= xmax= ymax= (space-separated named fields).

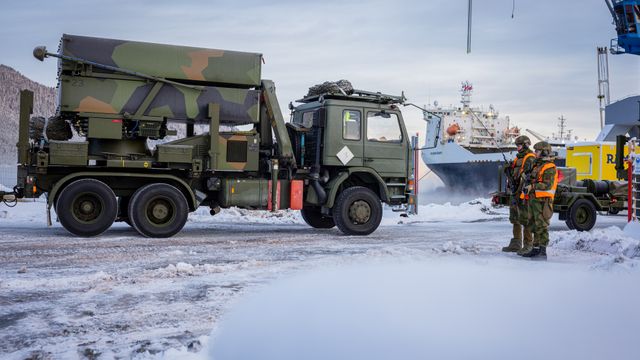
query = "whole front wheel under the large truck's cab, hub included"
xmin=333 ymin=186 xmax=382 ymax=235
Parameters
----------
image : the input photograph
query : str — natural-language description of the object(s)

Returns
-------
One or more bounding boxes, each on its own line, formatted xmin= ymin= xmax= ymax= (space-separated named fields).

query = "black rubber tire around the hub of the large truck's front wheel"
xmin=333 ymin=186 xmax=382 ymax=235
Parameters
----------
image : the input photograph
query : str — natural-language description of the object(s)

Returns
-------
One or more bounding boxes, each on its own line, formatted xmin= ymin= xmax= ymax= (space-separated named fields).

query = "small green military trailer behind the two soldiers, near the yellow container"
xmin=492 ymin=167 xmax=628 ymax=231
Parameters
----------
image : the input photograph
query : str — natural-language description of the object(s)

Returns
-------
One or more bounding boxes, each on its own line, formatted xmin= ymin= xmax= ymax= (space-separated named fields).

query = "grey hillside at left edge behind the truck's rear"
xmin=0 ymin=64 xmax=56 ymax=164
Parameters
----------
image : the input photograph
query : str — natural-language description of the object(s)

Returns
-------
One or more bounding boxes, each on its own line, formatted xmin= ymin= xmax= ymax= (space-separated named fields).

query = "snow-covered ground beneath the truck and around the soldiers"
xmin=0 ymin=199 xmax=640 ymax=359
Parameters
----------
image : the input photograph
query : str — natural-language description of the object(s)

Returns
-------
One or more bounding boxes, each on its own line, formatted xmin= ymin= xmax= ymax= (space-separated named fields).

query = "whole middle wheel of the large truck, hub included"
xmin=129 ymin=184 xmax=189 ymax=238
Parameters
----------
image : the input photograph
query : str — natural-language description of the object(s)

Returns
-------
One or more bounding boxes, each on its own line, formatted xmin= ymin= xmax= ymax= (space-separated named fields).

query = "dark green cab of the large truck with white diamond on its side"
xmin=288 ymin=90 xmax=413 ymax=208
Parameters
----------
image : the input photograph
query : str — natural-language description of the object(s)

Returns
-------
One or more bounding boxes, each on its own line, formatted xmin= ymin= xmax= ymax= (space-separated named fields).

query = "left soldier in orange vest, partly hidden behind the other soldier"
xmin=502 ymin=135 xmax=535 ymax=254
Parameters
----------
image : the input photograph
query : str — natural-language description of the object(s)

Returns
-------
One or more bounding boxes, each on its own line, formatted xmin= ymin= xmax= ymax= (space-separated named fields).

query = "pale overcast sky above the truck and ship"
xmin=0 ymin=0 xmax=640 ymax=139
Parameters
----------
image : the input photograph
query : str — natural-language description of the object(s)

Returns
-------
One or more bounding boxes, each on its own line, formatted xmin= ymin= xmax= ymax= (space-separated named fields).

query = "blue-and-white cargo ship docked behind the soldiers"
xmin=421 ymin=82 xmax=521 ymax=193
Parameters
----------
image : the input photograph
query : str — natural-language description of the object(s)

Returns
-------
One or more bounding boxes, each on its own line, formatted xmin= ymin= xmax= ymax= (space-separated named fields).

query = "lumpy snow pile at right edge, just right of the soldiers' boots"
xmin=550 ymin=226 xmax=640 ymax=258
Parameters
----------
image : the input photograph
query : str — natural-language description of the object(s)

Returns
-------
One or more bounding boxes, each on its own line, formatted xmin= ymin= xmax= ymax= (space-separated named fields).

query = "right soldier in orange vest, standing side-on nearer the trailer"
xmin=522 ymin=141 xmax=558 ymax=260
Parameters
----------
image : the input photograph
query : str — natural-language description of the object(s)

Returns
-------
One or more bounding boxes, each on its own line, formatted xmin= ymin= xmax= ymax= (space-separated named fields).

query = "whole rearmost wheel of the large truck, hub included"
xmin=55 ymin=179 xmax=118 ymax=237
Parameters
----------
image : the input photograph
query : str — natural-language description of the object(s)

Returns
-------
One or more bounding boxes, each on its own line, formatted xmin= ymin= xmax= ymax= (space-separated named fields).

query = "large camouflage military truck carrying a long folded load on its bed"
xmin=0 ymin=34 xmax=415 ymax=237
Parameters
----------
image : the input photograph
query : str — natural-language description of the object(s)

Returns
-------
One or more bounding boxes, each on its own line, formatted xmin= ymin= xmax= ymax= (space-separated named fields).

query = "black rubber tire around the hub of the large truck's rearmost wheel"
xmin=55 ymin=179 xmax=118 ymax=237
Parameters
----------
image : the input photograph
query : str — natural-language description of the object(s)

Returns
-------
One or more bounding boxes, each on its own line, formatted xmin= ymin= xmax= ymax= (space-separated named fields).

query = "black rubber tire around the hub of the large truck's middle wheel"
xmin=129 ymin=183 xmax=189 ymax=238
